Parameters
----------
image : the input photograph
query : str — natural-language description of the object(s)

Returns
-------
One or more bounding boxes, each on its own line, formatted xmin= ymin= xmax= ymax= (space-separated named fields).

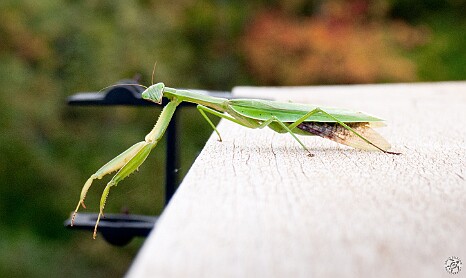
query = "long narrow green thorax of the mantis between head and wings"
xmin=163 ymin=87 xmax=228 ymax=112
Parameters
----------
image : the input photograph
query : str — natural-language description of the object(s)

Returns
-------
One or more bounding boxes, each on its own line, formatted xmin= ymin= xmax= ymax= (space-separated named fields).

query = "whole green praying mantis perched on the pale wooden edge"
xmin=71 ymin=83 xmax=398 ymax=238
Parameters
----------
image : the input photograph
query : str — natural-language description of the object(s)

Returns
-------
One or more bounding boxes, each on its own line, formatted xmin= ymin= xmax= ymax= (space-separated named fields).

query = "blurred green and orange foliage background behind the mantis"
xmin=0 ymin=0 xmax=466 ymax=277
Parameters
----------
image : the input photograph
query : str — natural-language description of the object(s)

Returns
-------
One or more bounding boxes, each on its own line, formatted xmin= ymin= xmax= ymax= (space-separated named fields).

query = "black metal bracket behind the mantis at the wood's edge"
xmin=65 ymin=79 xmax=231 ymax=246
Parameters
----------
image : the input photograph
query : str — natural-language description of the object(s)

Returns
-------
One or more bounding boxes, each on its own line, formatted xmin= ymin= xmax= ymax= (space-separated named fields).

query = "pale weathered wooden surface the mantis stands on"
xmin=128 ymin=82 xmax=466 ymax=277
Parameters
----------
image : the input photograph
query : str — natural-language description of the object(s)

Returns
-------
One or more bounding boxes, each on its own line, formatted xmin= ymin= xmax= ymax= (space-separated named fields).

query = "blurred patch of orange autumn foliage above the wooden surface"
xmin=241 ymin=11 xmax=423 ymax=85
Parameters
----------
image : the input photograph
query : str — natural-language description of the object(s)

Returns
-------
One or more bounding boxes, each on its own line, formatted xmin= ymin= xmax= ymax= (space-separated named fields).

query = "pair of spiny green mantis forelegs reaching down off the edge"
xmin=71 ymin=100 xmax=180 ymax=238
